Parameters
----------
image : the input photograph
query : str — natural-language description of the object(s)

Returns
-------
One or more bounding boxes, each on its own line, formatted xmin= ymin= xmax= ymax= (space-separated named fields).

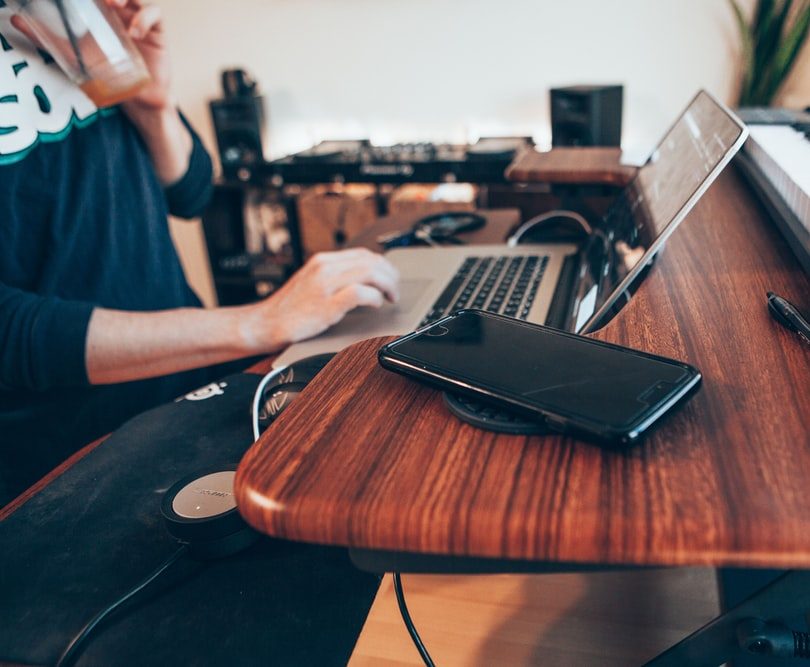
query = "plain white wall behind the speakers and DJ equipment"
xmin=157 ymin=0 xmax=810 ymax=304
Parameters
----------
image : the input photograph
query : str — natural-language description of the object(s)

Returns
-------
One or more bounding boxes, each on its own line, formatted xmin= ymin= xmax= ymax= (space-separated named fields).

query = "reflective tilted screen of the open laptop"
xmin=573 ymin=91 xmax=747 ymax=332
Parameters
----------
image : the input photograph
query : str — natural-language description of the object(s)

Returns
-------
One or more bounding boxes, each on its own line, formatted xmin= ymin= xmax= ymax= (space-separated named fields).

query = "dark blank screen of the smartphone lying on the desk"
xmin=391 ymin=312 xmax=694 ymax=429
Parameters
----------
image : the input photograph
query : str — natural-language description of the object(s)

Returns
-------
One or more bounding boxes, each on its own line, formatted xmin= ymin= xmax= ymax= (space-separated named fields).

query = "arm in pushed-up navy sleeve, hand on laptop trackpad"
xmin=0 ymin=249 xmax=399 ymax=391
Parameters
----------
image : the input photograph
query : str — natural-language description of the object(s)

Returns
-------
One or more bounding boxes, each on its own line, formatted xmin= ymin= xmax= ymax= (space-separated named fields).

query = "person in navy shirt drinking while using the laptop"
xmin=0 ymin=0 xmax=398 ymax=506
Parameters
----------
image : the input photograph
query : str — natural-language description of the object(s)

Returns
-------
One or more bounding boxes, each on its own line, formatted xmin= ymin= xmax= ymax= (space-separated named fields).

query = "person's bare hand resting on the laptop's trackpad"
xmin=238 ymin=248 xmax=399 ymax=353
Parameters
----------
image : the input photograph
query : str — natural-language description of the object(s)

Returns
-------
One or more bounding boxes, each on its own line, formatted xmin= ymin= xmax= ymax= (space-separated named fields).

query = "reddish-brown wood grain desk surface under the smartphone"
xmin=236 ymin=168 xmax=810 ymax=567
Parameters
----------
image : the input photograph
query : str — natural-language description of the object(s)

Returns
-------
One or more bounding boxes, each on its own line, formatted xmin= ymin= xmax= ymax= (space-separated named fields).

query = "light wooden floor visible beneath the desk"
xmin=349 ymin=568 xmax=719 ymax=667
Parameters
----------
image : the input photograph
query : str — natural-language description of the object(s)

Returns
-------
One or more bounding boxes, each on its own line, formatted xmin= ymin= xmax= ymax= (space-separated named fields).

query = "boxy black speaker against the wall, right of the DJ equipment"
xmin=551 ymin=86 xmax=624 ymax=146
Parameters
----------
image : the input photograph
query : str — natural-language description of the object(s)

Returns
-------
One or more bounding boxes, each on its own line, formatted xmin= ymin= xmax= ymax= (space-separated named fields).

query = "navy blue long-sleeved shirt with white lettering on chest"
xmin=0 ymin=9 xmax=218 ymax=506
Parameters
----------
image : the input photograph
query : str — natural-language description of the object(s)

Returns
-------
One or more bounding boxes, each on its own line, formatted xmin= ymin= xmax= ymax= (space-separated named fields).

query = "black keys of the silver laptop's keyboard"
xmin=419 ymin=255 xmax=548 ymax=327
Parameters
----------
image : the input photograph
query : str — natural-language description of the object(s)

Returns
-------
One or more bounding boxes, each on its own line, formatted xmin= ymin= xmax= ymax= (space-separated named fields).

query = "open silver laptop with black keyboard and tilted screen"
xmin=273 ymin=90 xmax=748 ymax=368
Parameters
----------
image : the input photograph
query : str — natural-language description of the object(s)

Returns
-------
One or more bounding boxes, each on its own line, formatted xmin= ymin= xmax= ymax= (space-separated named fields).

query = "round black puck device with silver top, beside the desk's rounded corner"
xmin=160 ymin=466 xmax=260 ymax=560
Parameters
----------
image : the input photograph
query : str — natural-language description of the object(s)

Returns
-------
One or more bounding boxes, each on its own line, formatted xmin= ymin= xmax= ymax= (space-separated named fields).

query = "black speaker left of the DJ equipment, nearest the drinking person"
xmin=210 ymin=70 xmax=265 ymax=181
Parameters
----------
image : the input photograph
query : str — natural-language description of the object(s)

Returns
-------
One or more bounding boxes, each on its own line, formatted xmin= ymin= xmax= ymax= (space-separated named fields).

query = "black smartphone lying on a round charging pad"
xmin=378 ymin=310 xmax=701 ymax=445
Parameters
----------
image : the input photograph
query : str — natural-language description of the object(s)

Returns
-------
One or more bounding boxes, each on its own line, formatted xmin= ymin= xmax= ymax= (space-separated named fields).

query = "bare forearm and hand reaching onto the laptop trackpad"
xmin=86 ymin=249 xmax=398 ymax=384
